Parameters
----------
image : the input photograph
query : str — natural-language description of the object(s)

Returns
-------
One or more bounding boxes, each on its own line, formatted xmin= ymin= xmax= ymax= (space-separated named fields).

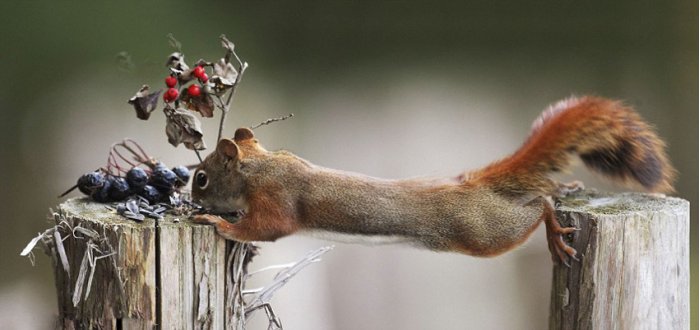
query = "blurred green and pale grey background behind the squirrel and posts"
xmin=0 ymin=0 xmax=698 ymax=329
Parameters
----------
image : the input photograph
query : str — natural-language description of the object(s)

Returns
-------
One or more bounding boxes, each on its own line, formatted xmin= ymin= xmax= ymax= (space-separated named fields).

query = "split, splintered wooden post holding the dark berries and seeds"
xmin=43 ymin=198 xmax=242 ymax=329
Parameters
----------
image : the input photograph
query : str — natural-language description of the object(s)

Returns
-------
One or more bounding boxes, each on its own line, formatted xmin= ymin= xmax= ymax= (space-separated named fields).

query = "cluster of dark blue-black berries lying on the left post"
xmin=77 ymin=162 xmax=190 ymax=204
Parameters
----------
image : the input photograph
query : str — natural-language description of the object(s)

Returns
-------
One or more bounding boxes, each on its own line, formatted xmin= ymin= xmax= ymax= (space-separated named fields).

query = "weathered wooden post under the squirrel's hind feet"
xmin=549 ymin=192 xmax=690 ymax=329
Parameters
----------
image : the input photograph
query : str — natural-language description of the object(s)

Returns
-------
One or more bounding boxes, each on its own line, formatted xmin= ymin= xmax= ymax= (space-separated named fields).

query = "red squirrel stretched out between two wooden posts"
xmin=192 ymin=97 xmax=675 ymax=264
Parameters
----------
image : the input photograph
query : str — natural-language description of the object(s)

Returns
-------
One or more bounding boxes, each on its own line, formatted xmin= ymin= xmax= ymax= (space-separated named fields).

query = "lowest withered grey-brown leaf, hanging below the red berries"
xmin=163 ymin=107 xmax=206 ymax=150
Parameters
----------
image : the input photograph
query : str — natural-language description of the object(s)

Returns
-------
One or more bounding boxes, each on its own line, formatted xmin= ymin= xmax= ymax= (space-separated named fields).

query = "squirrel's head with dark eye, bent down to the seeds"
xmin=192 ymin=128 xmax=267 ymax=214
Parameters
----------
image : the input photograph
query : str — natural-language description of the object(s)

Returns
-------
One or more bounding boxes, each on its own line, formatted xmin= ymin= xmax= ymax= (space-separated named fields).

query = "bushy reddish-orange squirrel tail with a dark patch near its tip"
xmin=470 ymin=97 xmax=675 ymax=195
